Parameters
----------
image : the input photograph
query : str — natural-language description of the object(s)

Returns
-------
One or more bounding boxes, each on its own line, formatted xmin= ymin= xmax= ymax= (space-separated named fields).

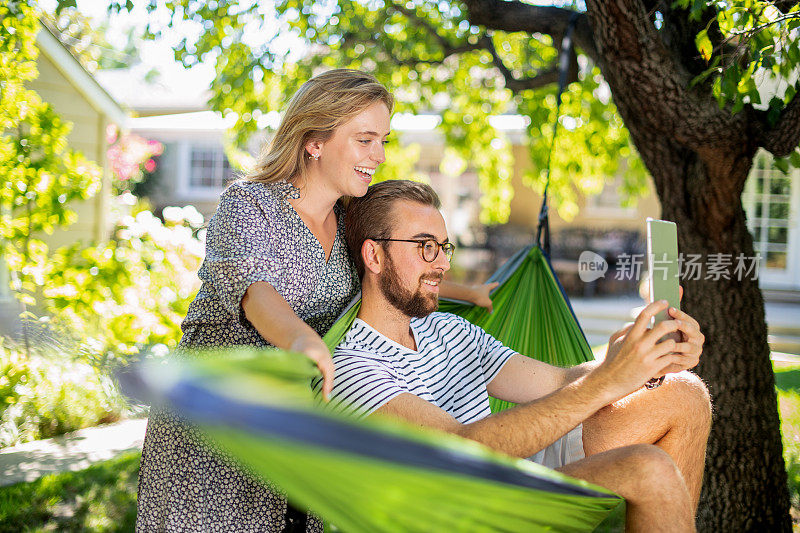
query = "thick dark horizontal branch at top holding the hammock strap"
xmin=464 ymin=0 xmax=600 ymax=63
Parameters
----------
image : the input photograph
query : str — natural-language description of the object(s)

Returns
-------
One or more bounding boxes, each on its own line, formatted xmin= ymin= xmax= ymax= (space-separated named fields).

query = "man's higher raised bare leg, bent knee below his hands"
xmin=583 ymin=372 xmax=711 ymax=513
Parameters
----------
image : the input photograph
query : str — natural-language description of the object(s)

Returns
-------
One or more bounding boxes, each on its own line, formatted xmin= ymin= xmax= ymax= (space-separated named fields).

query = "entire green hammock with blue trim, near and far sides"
xmin=123 ymin=246 xmax=625 ymax=533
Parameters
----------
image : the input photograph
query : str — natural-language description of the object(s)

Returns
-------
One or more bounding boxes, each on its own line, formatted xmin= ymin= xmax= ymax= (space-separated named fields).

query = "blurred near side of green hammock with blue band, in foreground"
xmin=126 ymin=350 xmax=625 ymax=533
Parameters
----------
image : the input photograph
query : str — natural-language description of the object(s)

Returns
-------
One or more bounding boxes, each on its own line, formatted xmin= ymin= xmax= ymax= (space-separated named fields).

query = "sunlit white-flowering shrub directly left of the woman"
xmin=43 ymin=197 xmax=204 ymax=361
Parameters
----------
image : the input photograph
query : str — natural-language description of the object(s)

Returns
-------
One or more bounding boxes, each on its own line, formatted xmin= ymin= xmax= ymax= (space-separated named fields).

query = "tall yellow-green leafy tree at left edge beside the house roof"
xmin=0 ymin=1 xmax=101 ymax=304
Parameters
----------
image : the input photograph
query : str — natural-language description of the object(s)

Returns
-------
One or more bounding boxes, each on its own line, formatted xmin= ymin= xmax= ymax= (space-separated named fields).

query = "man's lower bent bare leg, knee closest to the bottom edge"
xmin=558 ymin=444 xmax=695 ymax=532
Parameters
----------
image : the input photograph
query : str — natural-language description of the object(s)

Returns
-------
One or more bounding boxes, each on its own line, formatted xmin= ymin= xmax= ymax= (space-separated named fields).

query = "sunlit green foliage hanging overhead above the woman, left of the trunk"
xmin=104 ymin=0 xmax=646 ymax=222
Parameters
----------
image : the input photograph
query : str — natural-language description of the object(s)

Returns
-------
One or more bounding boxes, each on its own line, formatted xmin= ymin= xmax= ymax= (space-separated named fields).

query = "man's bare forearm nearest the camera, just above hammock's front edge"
xmin=455 ymin=365 xmax=618 ymax=457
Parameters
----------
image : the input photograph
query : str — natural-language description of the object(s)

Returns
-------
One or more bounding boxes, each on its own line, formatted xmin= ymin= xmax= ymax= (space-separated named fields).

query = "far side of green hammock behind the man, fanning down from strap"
xmin=324 ymin=246 xmax=594 ymax=412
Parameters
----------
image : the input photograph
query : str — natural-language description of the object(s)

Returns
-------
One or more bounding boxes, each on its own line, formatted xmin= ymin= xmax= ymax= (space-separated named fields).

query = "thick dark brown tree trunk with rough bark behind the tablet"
xmin=587 ymin=0 xmax=791 ymax=533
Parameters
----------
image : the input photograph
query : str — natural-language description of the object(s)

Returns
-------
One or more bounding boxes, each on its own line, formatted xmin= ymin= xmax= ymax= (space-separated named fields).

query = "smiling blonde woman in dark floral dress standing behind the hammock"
xmin=136 ymin=69 xmax=492 ymax=532
